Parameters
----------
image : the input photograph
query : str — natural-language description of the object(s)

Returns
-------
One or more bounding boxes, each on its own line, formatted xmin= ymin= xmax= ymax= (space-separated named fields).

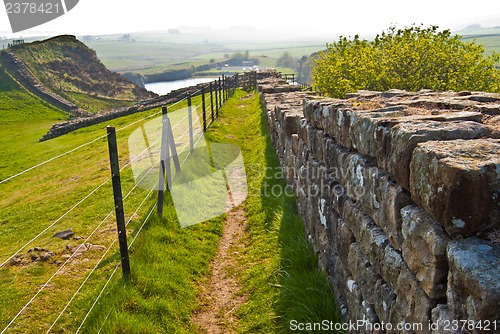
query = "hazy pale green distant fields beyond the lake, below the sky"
xmin=79 ymin=28 xmax=500 ymax=74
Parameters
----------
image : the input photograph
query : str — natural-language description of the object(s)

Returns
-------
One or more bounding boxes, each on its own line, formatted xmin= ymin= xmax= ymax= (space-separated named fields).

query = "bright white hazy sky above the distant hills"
xmin=0 ymin=0 xmax=500 ymax=37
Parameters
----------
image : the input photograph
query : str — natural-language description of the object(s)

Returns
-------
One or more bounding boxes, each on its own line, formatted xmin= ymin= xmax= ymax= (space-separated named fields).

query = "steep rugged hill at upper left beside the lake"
xmin=0 ymin=35 xmax=156 ymax=116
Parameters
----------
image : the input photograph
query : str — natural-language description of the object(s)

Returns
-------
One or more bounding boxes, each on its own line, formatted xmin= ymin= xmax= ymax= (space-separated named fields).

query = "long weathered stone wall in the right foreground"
xmin=260 ymin=78 xmax=500 ymax=333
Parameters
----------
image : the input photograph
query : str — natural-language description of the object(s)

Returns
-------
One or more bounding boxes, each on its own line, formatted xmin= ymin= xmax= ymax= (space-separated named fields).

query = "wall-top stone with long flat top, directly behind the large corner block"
xmin=376 ymin=121 xmax=489 ymax=190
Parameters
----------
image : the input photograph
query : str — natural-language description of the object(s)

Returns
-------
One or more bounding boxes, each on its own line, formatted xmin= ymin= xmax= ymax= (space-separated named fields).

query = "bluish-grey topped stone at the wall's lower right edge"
xmin=447 ymin=237 xmax=500 ymax=321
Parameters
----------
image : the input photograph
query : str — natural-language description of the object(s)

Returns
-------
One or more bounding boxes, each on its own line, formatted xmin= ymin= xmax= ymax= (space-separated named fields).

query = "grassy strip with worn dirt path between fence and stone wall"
xmin=56 ymin=87 xmax=338 ymax=334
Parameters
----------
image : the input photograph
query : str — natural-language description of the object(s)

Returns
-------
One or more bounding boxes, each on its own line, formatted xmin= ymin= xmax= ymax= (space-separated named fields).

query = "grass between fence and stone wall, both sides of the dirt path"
xmin=71 ymin=92 xmax=337 ymax=333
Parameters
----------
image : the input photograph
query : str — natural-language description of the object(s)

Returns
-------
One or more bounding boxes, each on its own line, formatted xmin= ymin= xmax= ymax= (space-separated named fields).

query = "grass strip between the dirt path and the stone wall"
xmin=202 ymin=88 xmax=339 ymax=333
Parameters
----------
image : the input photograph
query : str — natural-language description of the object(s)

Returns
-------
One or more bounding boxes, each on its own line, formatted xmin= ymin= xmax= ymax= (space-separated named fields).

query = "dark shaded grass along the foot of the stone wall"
xmin=261 ymin=103 xmax=340 ymax=333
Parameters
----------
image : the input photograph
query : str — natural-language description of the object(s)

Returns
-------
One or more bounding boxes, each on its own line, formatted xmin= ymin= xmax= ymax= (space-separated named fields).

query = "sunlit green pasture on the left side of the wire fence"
xmin=0 ymin=69 xmax=209 ymax=333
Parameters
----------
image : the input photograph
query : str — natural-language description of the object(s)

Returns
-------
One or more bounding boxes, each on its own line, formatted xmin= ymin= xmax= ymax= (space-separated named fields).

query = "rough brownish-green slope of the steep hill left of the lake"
xmin=4 ymin=36 xmax=152 ymax=112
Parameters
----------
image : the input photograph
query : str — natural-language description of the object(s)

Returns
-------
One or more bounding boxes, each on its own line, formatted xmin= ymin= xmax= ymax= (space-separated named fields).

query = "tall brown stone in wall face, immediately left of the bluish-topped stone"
xmin=401 ymin=206 xmax=450 ymax=299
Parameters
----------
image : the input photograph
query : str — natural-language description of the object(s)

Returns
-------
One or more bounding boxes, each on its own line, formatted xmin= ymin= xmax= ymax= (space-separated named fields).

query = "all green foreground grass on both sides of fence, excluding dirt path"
xmin=0 ymin=73 xmax=335 ymax=333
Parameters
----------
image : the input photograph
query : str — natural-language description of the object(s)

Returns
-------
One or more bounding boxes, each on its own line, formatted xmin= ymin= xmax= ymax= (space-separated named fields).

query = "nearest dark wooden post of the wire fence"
xmin=106 ymin=126 xmax=130 ymax=279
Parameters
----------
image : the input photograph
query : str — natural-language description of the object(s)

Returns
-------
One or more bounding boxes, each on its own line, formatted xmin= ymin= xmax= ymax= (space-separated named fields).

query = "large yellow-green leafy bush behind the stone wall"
xmin=313 ymin=26 xmax=500 ymax=97
